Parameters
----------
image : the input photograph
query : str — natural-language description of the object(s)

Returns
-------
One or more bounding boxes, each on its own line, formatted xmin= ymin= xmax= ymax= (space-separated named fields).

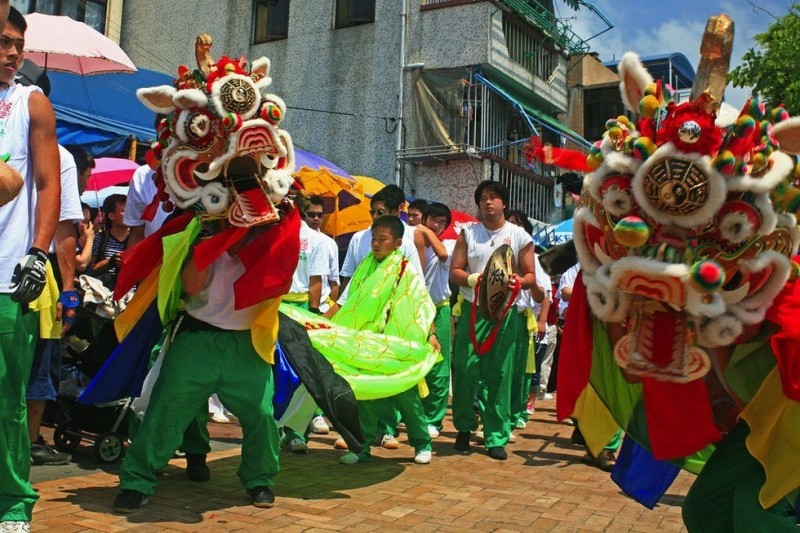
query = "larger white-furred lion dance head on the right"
xmin=552 ymin=15 xmax=800 ymax=382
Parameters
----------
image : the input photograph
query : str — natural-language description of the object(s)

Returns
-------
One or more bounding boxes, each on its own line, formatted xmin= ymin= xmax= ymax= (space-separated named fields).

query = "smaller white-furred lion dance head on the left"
xmin=136 ymin=35 xmax=294 ymax=227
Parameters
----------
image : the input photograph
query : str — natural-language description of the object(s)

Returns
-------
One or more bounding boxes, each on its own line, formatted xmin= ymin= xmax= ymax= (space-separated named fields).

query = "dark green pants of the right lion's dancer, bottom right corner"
xmin=682 ymin=422 xmax=798 ymax=533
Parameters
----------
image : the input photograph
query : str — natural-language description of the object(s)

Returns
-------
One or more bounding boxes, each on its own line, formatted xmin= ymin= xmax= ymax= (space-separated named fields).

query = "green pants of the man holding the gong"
xmin=453 ymin=302 xmax=517 ymax=448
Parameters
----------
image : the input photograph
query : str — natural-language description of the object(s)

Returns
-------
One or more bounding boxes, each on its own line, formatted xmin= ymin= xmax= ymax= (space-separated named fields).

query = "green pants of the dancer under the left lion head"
xmin=120 ymin=330 xmax=280 ymax=494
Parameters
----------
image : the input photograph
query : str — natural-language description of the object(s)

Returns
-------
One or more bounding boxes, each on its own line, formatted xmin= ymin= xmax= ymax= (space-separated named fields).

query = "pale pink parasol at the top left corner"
xmin=25 ymin=13 xmax=136 ymax=76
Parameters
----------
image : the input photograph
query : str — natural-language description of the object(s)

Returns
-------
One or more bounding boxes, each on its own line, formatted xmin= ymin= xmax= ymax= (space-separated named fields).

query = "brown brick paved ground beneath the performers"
xmin=32 ymin=402 xmax=692 ymax=533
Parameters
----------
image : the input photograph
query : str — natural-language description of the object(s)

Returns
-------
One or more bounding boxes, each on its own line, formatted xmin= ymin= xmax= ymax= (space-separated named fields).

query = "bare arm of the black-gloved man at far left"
xmin=28 ymin=93 xmax=61 ymax=250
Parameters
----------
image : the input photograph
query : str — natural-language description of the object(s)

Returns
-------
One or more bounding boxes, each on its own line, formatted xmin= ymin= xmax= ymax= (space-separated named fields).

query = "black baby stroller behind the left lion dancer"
xmin=49 ymin=282 xmax=132 ymax=463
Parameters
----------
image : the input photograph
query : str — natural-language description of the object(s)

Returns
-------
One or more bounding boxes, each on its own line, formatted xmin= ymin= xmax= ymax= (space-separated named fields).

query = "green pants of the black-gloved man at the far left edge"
xmin=0 ymin=294 xmax=39 ymax=522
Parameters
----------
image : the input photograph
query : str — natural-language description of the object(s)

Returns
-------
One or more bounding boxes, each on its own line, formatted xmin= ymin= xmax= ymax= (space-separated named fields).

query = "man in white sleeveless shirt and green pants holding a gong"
xmin=450 ymin=180 xmax=536 ymax=460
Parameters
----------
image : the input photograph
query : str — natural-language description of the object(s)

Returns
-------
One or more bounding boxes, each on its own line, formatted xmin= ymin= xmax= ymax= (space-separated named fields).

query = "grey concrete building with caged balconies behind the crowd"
xmin=14 ymin=0 xmax=605 ymax=221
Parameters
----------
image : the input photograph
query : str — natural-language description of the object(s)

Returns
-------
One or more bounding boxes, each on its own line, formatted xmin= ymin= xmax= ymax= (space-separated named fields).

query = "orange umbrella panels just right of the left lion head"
xmin=294 ymin=167 xmax=372 ymax=246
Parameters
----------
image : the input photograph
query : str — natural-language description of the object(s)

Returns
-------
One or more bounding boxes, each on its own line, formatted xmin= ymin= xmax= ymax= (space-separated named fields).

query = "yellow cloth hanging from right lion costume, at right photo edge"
xmin=741 ymin=366 xmax=800 ymax=509
